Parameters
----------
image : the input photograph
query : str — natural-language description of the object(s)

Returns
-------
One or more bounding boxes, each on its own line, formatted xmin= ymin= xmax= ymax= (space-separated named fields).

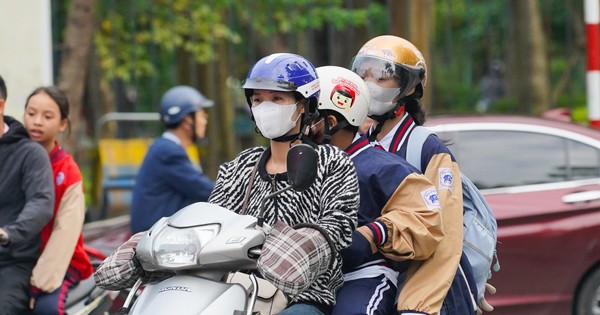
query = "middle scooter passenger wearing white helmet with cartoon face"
xmin=311 ymin=66 xmax=443 ymax=315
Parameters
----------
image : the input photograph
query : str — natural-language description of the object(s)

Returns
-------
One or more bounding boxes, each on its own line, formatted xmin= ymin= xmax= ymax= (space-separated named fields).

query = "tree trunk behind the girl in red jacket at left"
xmin=58 ymin=0 xmax=96 ymax=157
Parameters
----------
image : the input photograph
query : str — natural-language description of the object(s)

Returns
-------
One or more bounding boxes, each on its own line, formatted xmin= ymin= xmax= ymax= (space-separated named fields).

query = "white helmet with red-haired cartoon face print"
xmin=317 ymin=66 xmax=371 ymax=127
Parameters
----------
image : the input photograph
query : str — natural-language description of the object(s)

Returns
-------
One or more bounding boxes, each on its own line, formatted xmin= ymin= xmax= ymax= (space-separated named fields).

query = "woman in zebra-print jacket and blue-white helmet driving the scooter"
xmin=209 ymin=53 xmax=359 ymax=315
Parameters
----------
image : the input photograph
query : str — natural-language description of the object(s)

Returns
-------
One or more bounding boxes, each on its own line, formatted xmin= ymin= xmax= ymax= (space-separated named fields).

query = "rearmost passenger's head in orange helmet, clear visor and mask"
xmin=351 ymin=35 xmax=427 ymax=115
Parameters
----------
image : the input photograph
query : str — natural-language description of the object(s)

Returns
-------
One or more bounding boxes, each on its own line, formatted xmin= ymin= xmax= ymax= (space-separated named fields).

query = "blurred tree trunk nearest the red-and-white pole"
xmin=508 ymin=0 xmax=550 ymax=115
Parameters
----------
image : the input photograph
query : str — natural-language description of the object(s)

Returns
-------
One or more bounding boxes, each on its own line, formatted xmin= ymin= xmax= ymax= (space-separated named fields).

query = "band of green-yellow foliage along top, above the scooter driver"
xmin=95 ymin=0 xmax=384 ymax=83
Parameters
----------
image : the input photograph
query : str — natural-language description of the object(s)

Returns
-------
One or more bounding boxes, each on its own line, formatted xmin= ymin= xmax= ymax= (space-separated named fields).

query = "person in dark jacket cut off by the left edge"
xmin=0 ymin=76 xmax=54 ymax=315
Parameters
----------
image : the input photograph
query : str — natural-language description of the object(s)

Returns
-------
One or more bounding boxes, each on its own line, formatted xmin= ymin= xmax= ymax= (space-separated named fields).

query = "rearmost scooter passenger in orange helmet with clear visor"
xmin=351 ymin=35 xmax=477 ymax=315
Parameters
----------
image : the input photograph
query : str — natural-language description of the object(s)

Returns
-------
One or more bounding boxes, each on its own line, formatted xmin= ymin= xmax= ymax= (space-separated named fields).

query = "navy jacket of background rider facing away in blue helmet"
xmin=131 ymin=137 xmax=214 ymax=233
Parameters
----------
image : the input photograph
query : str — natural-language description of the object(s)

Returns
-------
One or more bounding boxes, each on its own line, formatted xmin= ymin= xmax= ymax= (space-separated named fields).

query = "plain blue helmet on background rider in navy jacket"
xmin=160 ymin=85 xmax=214 ymax=126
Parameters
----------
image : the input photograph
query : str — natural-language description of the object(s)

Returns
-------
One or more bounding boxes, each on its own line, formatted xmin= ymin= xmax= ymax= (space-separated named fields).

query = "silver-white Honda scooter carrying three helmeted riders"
xmin=121 ymin=144 xmax=317 ymax=315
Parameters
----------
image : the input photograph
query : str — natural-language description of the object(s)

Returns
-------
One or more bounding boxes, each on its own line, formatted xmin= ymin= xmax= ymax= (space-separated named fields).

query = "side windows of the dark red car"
xmin=440 ymin=130 xmax=600 ymax=189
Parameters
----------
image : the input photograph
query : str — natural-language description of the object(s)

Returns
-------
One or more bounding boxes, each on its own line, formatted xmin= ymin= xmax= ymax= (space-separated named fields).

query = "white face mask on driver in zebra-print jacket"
xmin=252 ymin=101 xmax=300 ymax=139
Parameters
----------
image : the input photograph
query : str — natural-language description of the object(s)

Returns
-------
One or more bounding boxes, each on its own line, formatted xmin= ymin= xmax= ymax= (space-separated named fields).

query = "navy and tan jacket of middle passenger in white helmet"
xmin=343 ymin=138 xmax=443 ymax=283
